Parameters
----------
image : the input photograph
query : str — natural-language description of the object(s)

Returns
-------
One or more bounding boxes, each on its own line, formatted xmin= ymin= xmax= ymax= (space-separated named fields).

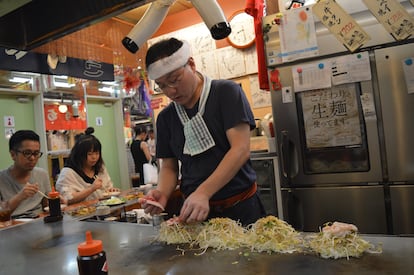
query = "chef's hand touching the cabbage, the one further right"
xmin=179 ymin=191 xmax=210 ymax=223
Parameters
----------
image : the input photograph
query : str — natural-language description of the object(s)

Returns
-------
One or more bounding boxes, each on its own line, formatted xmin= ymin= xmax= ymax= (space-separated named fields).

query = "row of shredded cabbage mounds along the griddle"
xmin=156 ymin=216 xmax=382 ymax=259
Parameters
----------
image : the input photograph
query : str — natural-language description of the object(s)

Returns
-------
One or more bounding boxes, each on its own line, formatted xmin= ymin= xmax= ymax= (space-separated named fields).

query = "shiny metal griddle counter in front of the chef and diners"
xmin=0 ymin=215 xmax=414 ymax=275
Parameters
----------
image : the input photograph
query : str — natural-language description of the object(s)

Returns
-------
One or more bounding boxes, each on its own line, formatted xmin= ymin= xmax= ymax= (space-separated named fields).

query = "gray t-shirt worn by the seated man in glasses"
xmin=0 ymin=167 xmax=51 ymax=216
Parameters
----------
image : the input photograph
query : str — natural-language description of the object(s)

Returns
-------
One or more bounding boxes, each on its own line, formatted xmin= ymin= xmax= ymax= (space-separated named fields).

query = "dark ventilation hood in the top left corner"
xmin=0 ymin=0 xmax=152 ymax=51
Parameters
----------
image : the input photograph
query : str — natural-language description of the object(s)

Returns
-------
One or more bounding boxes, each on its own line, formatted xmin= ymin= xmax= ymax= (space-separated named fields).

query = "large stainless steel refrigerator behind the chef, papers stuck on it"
xmin=263 ymin=0 xmax=414 ymax=234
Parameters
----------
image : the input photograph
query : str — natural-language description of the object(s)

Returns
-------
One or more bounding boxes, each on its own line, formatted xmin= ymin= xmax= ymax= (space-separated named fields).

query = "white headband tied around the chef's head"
xmin=147 ymin=41 xmax=191 ymax=80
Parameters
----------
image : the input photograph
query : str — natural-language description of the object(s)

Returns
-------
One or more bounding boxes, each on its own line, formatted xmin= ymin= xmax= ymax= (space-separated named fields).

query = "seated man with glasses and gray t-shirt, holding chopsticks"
xmin=0 ymin=130 xmax=51 ymax=217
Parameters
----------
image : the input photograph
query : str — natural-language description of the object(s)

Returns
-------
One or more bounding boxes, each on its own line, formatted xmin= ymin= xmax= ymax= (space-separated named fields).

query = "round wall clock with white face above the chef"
xmin=227 ymin=10 xmax=256 ymax=49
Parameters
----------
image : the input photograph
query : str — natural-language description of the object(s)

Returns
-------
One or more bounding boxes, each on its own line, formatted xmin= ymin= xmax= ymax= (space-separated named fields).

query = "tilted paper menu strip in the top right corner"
xmin=363 ymin=0 xmax=414 ymax=40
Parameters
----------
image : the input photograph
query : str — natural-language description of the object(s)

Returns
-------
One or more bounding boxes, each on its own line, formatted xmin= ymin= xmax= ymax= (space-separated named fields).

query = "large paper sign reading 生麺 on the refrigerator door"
xmin=301 ymin=84 xmax=362 ymax=148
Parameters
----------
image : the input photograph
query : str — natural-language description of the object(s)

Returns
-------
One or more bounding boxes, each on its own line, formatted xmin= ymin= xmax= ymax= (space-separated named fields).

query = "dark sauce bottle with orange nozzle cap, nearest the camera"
xmin=77 ymin=231 xmax=108 ymax=275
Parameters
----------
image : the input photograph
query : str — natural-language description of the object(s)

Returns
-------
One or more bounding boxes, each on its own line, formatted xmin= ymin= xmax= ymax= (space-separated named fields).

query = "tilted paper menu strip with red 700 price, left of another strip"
xmin=312 ymin=0 xmax=371 ymax=52
